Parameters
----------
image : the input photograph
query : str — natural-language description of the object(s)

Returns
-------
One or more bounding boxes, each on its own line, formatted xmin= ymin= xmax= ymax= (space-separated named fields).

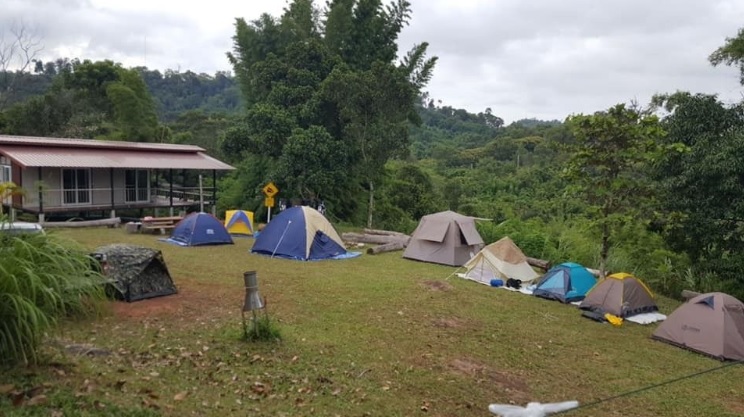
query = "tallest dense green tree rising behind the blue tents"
xmin=224 ymin=0 xmax=436 ymax=225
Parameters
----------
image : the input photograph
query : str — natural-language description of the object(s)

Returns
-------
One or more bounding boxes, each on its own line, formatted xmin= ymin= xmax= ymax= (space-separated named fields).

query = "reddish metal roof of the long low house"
xmin=0 ymin=135 xmax=234 ymax=170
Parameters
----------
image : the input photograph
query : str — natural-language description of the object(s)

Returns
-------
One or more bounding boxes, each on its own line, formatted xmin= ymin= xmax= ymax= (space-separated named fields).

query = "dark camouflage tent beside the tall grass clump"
xmin=92 ymin=244 xmax=178 ymax=302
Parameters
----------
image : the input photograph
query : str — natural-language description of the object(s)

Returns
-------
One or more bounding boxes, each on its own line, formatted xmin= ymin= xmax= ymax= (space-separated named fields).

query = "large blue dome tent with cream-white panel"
xmin=251 ymin=206 xmax=347 ymax=261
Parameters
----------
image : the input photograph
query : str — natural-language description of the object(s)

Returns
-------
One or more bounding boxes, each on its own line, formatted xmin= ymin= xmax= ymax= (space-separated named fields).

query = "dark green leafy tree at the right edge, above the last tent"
xmin=655 ymin=93 xmax=744 ymax=282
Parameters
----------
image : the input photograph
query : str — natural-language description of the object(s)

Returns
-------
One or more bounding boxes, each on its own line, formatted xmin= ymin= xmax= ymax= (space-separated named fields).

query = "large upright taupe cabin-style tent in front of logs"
xmin=403 ymin=211 xmax=483 ymax=266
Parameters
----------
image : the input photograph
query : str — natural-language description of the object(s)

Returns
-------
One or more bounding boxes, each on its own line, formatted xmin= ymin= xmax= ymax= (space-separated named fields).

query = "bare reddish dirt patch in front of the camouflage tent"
xmin=113 ymin=282 xmax=235 ymax=320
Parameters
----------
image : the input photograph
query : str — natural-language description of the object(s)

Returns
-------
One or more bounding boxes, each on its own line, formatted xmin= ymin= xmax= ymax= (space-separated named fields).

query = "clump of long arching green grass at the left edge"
xmin=0 ymin=221 xmax=104 ymax=363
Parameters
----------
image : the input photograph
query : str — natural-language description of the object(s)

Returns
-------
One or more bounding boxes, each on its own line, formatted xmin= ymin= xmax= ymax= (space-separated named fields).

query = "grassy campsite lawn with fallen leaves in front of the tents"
xmin=0 ymin=229 xmax=744 ymax=417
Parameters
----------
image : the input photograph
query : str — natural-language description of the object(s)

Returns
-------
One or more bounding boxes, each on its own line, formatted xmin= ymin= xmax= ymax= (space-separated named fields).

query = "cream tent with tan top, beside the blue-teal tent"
xmin=462 ymin=236 xmax=539 ymax=285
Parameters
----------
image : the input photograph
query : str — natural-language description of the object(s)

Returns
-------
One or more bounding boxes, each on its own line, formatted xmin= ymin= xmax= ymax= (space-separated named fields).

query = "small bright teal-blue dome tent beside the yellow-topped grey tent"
xmin=532 ymin=262 xmax=597 ymax=303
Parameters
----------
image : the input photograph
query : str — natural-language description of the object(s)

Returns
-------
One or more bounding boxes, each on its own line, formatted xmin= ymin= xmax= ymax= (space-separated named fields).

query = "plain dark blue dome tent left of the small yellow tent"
xmin=165 ymin=213 xmax=233 ymax=246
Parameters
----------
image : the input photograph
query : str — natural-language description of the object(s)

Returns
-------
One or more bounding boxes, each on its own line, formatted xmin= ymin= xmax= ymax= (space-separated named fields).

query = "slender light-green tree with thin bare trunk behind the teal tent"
xmin=564 ymin=104 xmax=664 ymax=278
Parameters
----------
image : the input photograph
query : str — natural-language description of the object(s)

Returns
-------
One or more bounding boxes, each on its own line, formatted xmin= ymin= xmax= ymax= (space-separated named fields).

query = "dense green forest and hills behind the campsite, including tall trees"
xmin=0 ymin=0 xmax=744 ymax=298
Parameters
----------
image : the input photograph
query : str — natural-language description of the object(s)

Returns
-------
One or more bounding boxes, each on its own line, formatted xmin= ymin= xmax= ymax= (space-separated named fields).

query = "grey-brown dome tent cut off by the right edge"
xmin=651 ymin=292 xmax=744 ymax=361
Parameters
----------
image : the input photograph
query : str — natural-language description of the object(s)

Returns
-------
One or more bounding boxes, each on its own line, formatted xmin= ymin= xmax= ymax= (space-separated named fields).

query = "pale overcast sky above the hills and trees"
xmin=0 ymin=0 xmax=744 ymax=122
